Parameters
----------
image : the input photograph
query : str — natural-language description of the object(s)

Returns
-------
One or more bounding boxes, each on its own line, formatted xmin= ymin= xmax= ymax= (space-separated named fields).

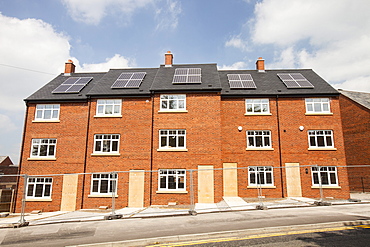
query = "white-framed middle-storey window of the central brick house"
xmin=159 ymin=130 xmax=186 ymax=148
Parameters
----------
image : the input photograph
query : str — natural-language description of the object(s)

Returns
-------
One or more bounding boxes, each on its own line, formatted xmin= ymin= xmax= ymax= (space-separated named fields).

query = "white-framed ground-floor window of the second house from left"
xmin=91 ymin=173 xmax=118 ymax=194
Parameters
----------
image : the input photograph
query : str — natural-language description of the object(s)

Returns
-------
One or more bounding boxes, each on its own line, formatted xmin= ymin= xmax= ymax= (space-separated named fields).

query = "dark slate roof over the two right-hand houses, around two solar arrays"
xmin=219 ymin=69 xmax=339 ymax=97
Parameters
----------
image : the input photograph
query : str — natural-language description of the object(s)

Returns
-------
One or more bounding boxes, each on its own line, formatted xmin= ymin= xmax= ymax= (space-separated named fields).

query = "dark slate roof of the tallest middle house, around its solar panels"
xmin=151 ymin=64 xmax=221 ymax=92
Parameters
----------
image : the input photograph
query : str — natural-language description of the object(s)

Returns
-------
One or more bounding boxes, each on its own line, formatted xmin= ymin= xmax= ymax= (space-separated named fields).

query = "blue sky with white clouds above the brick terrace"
xmin=0 ymin=0 xmax=370 ymax=164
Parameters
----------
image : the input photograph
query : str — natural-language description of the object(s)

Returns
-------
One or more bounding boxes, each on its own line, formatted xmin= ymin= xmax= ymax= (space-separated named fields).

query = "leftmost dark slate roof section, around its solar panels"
xmin=25 ymin=73 xmax=105 ymax=101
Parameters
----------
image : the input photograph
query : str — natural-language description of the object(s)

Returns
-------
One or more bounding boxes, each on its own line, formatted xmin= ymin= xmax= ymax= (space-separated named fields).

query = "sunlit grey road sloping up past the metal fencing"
xmin=0 ymin=204 xmax=370 ymax=247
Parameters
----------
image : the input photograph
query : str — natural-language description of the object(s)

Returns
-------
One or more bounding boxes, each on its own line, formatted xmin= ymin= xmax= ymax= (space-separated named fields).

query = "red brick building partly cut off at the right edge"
xmin=339 ymin=90 xmax=370 ymax=192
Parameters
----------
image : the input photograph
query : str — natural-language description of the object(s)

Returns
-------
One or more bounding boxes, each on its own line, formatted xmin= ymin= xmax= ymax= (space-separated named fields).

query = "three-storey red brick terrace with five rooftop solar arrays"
xmin=14 ymin=52 xmax=349 ymax=211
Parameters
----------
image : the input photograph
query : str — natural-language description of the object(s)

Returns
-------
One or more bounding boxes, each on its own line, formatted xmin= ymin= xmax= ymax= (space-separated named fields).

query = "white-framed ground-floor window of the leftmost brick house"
xmin=27 ymin=177 xmax=53 ymax=199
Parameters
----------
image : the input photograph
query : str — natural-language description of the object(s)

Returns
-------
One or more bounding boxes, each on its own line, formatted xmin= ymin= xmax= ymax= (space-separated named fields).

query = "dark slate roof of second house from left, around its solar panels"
xmin=88 ymin=68 xmax=158 ymax=96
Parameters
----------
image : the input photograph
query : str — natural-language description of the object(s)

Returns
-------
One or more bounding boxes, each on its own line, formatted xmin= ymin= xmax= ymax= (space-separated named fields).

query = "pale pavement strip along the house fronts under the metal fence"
xmin=0 ymin=193 xmax=370 ymax=228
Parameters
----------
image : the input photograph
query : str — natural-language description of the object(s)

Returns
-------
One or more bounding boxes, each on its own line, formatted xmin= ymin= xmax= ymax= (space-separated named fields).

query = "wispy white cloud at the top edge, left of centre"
xmin=62 ymin=0 xmax=154 ymax=25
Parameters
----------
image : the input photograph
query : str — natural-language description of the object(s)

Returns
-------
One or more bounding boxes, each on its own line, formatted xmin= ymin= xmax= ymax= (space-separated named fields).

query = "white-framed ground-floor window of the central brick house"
xmin=158 ymin=169 xmax=186 ymax=191
